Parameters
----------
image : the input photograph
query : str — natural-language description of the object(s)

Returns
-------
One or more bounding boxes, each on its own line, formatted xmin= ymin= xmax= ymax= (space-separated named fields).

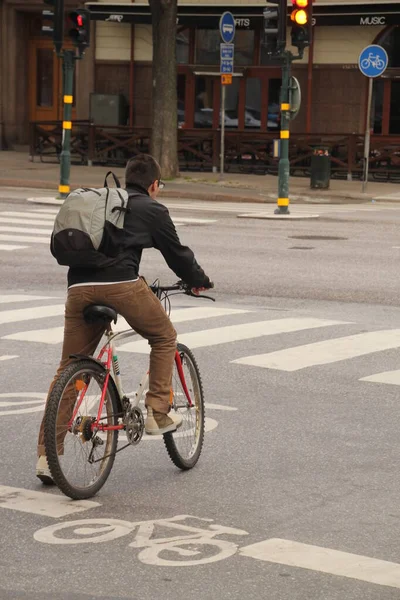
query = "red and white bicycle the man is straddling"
xmin=44 ymin=282 xmax=215 ymax=500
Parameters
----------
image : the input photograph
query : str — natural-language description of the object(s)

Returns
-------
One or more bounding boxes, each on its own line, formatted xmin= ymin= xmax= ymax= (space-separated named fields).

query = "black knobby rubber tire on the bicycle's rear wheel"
xmin=44 ymin=359 xmax=119 ymax=500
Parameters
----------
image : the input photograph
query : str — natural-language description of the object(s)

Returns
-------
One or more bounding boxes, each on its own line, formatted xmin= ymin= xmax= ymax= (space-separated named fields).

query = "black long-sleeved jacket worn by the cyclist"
xmin=68 ymin=186 xmax=210 ymax=287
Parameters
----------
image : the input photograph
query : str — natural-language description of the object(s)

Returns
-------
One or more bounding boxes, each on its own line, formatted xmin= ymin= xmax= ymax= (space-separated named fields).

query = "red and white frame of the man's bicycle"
xmin=68 ymin=325 xmax=193 ymax=431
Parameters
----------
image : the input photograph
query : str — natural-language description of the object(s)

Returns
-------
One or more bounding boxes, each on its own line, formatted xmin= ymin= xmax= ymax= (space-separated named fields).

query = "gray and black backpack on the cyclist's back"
xmin=51 ymin=171 xmax=129 ymax=268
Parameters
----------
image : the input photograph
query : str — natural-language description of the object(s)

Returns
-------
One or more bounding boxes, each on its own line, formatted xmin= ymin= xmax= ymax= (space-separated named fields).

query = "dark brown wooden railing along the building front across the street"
xmin=30 ymin=121 xmax=400 ymax=181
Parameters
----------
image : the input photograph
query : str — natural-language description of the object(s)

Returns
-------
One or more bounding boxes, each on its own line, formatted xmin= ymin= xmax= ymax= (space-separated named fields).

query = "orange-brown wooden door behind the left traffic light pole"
xmin=28 ymin=38 xmax=76 ymax=121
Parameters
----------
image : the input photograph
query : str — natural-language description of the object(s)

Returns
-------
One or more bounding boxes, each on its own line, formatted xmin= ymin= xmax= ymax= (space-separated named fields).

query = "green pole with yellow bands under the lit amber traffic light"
xmin=274 ymin=51 xmax=292 ymax=215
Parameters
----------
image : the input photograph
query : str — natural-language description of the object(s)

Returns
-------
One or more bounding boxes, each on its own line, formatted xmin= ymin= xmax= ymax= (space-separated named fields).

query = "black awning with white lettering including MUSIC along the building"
xmin=85 ymin=1 xmax=400 ymax=29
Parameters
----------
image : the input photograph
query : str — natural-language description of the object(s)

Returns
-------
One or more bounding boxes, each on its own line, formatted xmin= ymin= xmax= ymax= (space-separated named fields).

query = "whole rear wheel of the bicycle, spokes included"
xmin=44 ymin=359 xmax=119 ymax=500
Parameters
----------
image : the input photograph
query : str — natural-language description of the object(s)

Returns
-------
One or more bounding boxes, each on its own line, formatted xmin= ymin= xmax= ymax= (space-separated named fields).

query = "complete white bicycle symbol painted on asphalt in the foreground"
xmin=33 ymin=515 xmax=248 ymax=567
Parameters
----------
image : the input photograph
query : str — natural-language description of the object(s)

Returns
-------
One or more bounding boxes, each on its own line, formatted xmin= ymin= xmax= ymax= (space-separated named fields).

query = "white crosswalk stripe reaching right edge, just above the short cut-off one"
xmin=232 ymin=329 xmax=400 ymax=371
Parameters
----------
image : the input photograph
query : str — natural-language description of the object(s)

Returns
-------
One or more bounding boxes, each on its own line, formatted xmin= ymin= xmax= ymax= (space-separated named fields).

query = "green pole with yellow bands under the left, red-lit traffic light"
xmin=58 ymin=50 xmax=75 ymax=198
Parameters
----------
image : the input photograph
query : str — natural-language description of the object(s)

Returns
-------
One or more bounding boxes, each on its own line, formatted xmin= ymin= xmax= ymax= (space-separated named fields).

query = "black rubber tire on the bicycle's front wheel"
xmin=163 ymin=344 xmax=205 ymax=471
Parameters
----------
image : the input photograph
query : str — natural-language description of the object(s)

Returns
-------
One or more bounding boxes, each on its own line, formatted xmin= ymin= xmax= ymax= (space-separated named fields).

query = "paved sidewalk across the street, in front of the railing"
xmin=0 ymin=151 xmax=400 ymax=204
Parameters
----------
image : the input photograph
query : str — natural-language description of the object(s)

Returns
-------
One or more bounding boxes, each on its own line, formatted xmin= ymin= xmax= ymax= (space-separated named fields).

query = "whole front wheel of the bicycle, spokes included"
xmin=163 ymin=344 xmax=205 ymax=470
